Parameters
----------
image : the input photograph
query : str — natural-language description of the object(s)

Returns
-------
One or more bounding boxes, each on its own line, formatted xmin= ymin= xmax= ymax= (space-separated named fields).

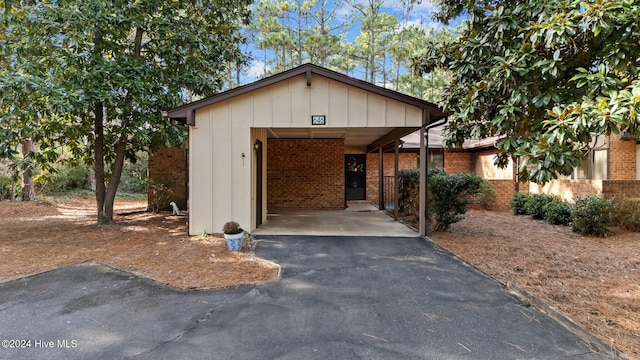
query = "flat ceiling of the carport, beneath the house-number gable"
xmin=268 ymin=127 xmax=418 ymax=146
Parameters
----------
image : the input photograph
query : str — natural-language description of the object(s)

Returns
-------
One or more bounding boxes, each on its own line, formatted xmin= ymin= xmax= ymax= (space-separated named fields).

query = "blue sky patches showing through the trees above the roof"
xmin=243 ymin=0 xmax=442 ymax=83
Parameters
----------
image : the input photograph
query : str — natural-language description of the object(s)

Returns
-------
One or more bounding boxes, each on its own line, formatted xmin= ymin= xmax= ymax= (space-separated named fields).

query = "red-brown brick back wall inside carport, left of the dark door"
xmin=267 ymin=139 xmax=345 ymax=212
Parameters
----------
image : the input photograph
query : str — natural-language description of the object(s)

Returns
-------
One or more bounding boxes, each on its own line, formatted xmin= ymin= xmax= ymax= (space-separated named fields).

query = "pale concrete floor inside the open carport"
xmin=252 ymin=202 xmax=418 ymax=237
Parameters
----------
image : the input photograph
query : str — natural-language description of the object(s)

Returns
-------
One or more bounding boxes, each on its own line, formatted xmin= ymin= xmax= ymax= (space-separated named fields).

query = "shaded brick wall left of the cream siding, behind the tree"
xmin=148 ymin=147 xmax=187 ymax=210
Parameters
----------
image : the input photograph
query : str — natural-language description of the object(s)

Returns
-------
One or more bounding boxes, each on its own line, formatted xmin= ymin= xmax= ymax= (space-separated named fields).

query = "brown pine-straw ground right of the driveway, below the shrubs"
xmin=431 ymin=211 xmax=640 ymax=359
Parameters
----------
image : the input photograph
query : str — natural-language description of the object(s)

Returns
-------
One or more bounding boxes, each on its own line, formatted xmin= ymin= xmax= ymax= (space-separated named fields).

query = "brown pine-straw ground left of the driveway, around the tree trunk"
xmin=0 ymin=199 xmax=279 ymax=289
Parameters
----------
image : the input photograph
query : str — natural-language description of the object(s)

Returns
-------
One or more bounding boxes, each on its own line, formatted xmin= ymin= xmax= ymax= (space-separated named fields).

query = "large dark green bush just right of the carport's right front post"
xmin=429 ymin=168 xmax=483 ymax=231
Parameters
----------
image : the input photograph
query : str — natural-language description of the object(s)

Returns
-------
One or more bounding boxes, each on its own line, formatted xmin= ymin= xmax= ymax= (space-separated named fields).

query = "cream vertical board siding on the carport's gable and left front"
xmin=189 ymin=75 xmax=430 ymax=234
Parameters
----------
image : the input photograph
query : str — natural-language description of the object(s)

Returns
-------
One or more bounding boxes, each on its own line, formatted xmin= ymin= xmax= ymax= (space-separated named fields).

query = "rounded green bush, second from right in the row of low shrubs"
xmin=571 ymin=196 xmax=613 ymax=236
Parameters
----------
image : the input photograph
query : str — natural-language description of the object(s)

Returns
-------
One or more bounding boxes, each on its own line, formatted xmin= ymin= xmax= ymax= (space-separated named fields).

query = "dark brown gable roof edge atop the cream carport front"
xmin=166 ymin=64 xmax=446 ymax=125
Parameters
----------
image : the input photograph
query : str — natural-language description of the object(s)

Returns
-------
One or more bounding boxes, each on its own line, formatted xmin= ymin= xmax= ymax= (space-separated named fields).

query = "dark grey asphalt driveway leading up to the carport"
xmin=0 ymin=236 xmax=610 ymax=359
